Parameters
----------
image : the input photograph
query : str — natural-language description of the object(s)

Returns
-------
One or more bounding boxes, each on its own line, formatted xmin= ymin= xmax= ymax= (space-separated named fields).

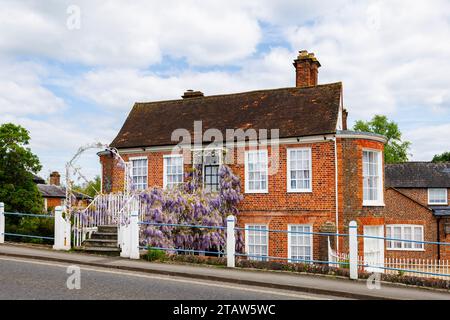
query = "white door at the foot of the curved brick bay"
xmin=364 ymin=226 xmax=384 ymax=273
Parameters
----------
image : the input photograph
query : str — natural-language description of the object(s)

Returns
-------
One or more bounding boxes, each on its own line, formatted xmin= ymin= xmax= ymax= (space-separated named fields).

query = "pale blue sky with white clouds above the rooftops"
xmin=0 ymin=0 xmax=450 ymax=184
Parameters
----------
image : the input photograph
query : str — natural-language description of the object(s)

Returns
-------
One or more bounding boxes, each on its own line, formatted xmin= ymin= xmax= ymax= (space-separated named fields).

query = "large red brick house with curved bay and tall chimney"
xmin=99 ymin=51 xmax=386 ymax=260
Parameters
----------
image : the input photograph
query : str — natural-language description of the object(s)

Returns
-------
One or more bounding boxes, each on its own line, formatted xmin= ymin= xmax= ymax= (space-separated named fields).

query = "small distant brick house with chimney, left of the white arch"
xmin=33 ymin=171 xmax=92 ymax=212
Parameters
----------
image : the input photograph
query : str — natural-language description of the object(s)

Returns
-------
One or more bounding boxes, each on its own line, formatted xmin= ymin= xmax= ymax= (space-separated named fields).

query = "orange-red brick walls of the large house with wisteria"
xmin=101 ymin=139 xmax=384 ymax=259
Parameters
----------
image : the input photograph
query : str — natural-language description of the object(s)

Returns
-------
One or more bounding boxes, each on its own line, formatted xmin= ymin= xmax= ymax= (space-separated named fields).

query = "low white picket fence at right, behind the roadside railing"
xmin=328 ymin=239 xmax=450 ymax=280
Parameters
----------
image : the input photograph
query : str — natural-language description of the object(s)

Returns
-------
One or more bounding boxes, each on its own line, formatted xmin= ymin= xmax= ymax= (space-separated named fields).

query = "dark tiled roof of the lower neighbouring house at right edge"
xmin=385 ymin=162 xmax=450 ymax=188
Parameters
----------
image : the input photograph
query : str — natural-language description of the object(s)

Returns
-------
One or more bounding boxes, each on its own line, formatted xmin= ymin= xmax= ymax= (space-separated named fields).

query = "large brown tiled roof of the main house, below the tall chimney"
xmin=111 ymin=82 xmax=342 ymax=148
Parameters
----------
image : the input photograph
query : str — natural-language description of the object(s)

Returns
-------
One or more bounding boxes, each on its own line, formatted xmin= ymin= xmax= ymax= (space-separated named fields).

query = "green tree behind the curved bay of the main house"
xmin=353 ymin=115 xmax=411 ymax=163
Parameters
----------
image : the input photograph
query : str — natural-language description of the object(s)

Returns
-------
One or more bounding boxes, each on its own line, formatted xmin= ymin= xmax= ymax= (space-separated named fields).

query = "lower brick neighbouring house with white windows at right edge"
xmin=385 ymin=162 xmax=450 ymax=259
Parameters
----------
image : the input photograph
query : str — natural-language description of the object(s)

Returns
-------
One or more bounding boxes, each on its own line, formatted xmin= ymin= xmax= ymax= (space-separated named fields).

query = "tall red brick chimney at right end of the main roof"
xmin=294 ymin=50 xmax=320 ymax=88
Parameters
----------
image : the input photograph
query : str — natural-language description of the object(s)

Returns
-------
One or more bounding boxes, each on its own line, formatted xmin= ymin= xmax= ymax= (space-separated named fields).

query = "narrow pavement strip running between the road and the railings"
xmin=0 ymin=244 xmax=450 ymax=300
